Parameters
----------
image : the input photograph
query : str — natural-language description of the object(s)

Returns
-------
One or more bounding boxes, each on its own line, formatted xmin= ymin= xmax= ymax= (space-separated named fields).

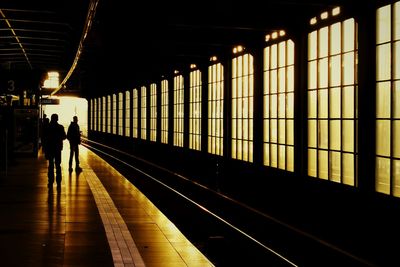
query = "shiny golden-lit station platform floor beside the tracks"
xmin=0 ymin=141 xmax=213 ymax=267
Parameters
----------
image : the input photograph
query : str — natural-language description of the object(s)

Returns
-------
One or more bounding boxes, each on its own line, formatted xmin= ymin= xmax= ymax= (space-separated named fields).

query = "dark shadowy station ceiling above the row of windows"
xmin=0 ymin=0 xmax=370 ymax=96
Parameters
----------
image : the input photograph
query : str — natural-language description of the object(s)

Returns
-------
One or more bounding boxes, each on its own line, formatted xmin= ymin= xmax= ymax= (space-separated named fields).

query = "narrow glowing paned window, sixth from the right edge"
xmin=189 ymin=70 xmax=202 ymax=150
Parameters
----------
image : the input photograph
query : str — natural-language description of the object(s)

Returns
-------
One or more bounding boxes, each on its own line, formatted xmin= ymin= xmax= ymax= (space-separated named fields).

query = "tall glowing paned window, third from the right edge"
xmin=263 ymin=37 xmax=294 ymax=171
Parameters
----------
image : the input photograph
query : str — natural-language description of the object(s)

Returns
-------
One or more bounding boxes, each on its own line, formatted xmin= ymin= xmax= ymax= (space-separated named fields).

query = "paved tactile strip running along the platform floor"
xmin=81 ymin=168 xmax=145 ymax=267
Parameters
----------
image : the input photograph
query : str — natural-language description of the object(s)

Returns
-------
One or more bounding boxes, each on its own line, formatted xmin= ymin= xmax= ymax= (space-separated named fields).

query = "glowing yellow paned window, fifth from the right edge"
xmin=207 ymin=63 xmax=224 ymax=156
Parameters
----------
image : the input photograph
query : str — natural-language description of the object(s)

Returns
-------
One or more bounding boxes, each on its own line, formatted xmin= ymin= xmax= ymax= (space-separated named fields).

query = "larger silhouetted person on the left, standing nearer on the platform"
xmin=45 ymin=114 xmax=66 ymax=188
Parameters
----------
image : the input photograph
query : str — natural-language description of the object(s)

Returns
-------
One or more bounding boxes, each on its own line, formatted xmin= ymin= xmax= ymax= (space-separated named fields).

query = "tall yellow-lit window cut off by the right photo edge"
xmin=375 ymin=2 xmax=400 ymax=197
